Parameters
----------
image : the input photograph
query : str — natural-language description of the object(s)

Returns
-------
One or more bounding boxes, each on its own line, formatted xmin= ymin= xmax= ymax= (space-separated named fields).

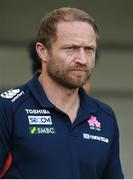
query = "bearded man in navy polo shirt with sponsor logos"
xmin=0 ymin=8 xmax=123 ymax=179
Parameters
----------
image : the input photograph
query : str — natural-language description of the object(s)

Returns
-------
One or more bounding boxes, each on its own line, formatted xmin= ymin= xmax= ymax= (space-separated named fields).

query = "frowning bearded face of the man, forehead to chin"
xmin=46 ymin=21 xmax=96 ymax=89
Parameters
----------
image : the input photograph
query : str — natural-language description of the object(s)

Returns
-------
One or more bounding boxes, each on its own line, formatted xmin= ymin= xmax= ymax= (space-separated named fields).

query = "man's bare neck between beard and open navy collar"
xmin=39 ymin=74 xmax=80 ymax=122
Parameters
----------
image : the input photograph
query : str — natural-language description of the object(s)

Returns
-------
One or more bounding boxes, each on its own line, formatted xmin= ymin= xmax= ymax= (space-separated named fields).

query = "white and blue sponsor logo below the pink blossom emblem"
xmin=83 ymin=133 xmax=109 ymax=143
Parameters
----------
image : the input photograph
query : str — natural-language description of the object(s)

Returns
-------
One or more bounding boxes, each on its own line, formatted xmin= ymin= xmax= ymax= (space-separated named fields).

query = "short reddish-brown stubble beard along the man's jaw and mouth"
xmin=46 ymin=52 xmax=93 ymax=89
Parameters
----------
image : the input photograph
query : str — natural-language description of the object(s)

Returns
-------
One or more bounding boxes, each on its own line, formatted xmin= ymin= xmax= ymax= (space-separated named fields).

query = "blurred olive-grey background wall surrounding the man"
xmin=0 ymin=0 xmax=133 ymax=178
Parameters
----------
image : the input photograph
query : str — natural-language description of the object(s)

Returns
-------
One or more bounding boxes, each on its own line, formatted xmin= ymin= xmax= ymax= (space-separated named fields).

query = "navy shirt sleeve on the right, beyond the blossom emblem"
xmin=102 ymin=115 xmax=124 ymax=179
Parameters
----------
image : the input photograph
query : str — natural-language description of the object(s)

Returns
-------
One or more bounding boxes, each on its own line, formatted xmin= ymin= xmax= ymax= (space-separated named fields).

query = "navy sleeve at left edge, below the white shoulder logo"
xmin=0 ymin=98 xmax=13 ymax=172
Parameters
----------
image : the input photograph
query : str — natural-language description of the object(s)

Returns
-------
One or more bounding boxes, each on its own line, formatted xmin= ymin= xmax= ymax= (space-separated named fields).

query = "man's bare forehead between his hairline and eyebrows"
xmin=57 ymin=21 xmax=96 ymax=44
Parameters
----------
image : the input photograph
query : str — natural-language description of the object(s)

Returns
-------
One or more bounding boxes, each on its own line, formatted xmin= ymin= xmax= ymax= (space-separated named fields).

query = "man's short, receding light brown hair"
xmin=37 ymin=7 xmax=98 ymax=49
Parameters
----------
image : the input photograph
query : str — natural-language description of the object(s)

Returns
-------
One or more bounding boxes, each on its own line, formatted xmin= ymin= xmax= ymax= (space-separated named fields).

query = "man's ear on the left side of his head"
xmin=36 ymin=42 xmax=48 ymax=62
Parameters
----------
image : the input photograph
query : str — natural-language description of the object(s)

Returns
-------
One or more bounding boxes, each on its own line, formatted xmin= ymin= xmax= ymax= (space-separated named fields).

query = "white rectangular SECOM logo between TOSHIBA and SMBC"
xmin=28 ymin=116 xmax=52 ymax=125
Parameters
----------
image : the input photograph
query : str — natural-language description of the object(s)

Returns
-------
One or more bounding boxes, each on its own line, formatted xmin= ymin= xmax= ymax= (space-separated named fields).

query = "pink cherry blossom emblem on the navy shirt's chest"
xmin=87 ymin=116 xmax=101 ymax=131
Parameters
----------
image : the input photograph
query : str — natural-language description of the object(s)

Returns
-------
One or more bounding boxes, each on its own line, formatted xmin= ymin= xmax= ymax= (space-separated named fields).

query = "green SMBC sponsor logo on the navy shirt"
xmin=29 ymin=126 xmax=55 ymax=134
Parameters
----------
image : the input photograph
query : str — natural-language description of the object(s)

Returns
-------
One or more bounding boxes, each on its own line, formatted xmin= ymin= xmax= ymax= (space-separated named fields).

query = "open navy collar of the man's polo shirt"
xmin=27 ymin=72 xmax=98 ymax=116
